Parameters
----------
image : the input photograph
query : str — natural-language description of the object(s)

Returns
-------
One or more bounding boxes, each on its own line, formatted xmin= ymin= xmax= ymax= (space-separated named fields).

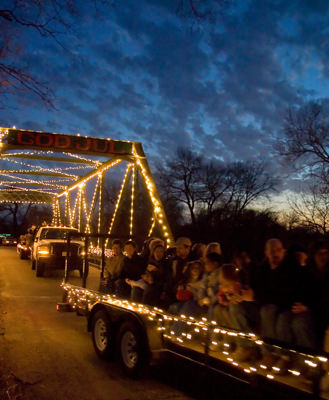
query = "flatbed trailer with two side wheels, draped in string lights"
xmin=57 ymin=234 xmax=329 ymax=399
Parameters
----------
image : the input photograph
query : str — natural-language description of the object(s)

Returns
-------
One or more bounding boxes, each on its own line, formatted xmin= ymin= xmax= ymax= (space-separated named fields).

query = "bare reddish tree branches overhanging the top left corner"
xmin=0 ymin=0 xmax=112 ymax=106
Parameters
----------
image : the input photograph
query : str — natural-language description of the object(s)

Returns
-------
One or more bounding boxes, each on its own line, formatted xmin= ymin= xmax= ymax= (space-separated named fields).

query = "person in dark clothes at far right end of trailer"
xmin=302 ymin=241 xmax=329 ymax=350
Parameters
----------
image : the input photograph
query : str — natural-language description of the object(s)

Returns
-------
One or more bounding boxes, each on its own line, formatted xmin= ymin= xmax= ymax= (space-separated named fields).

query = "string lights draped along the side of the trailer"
xmin=61 ymin=280 xmax=328 ymax=390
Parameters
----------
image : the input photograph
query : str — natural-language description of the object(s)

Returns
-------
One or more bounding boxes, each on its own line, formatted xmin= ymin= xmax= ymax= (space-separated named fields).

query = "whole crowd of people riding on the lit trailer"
xmin=102 ymin=237 xmax=329 ymax=370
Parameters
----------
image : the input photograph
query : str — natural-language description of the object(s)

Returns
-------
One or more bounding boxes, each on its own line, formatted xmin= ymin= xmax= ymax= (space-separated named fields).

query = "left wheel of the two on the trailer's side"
xmin=91 ymin=310 xmax=115 ymax=360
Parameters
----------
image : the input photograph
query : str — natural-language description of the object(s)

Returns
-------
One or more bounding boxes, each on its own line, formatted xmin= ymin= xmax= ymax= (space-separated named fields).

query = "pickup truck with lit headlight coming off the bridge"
xmin=31 ymin=226 xmax=85 ymax=277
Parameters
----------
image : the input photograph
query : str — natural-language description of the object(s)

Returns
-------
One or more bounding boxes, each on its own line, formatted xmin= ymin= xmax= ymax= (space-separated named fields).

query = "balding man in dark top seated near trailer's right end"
xmin=251 ymin=239 xmax=315 ymax=371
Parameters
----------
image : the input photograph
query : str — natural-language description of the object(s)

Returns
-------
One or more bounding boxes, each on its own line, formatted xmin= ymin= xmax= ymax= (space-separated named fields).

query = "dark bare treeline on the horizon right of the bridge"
xmin=155 ymin=148 xmax=321 ymax=260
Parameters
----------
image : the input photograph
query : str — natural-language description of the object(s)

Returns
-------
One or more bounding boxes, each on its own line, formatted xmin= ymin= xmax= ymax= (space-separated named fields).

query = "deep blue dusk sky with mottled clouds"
xmin=0 ymin=0 xmax=329 ymax=209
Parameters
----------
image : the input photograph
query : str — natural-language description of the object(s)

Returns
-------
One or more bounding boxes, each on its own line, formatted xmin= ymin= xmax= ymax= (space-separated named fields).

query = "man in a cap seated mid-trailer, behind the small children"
xmin=161 ymin=237 xmax=192 ymax=307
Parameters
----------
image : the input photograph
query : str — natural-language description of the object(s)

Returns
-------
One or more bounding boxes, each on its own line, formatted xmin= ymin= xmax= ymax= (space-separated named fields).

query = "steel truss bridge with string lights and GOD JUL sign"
xmin=0 ymin=128 xmax=173 ymax=246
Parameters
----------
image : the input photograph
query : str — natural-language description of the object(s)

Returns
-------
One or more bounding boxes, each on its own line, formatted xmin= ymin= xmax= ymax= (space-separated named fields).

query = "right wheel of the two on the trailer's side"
xmin=118 ymin=322 xmax=146 ymax=378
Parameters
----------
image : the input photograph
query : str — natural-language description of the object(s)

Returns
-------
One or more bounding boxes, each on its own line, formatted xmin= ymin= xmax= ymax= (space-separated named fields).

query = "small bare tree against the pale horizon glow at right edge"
xmin=288 ymin=186 xmax=329 ymax=234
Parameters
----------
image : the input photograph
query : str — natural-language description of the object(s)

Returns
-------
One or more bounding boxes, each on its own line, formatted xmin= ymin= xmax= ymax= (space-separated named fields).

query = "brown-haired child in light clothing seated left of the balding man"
xmin=213 ymin=264 xmax=259 ymax=361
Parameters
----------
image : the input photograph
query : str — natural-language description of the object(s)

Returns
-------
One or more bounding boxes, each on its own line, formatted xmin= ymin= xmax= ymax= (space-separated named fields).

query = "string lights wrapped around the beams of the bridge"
xmin=0 ymin=128 xmax=172 ymax=245
